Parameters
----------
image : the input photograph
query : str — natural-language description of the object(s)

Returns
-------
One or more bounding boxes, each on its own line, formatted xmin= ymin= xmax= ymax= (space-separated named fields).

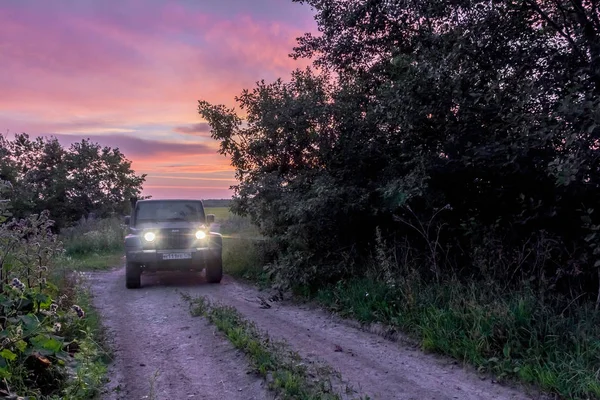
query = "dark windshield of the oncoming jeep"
xmin=135 ymin=201 xmax=204 ymax=224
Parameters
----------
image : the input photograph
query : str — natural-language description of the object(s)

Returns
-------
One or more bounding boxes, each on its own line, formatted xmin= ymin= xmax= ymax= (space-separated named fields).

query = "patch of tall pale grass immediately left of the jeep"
xmin=60 ymin=218 xmax=125 ymax=257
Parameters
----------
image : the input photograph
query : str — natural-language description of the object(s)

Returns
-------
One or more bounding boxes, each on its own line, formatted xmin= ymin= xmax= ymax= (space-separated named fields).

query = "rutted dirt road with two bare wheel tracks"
xmin=89 ymin=268 xmax=536 ymax=400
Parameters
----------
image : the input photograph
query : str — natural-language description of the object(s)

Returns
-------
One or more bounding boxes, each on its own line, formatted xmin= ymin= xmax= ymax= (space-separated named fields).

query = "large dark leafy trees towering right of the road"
xmin=199 ymin=0 xmax=600 ymax=305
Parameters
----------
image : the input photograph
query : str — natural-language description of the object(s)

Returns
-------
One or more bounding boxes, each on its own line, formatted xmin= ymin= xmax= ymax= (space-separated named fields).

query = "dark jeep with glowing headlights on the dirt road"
xmin=125 ymin=199 xmax=223 ymax=289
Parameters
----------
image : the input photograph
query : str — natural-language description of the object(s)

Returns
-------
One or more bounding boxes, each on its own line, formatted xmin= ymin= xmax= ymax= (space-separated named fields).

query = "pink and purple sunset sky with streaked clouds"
xmin=0 ymin=0 xmax=316 ymax=199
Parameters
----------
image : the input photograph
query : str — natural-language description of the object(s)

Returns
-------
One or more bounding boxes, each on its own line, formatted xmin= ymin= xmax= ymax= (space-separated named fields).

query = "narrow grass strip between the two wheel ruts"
xmin=182 ymin=294 xmax=368 ymax=400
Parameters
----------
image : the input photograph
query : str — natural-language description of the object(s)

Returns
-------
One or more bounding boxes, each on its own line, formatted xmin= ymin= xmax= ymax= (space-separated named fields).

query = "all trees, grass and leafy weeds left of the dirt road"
xmin=0 ymin=134 xmax=145 ymax=400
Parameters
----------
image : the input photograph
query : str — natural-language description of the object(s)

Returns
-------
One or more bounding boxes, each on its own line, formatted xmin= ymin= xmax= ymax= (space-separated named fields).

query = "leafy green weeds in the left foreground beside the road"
xmin=0 ymin=184 xmax=103 ymax=399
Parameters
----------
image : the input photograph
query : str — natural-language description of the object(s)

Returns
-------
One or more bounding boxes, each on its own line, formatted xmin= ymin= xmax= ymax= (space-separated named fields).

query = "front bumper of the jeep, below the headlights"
xmin=125 ymin=247 xmax=215 ymax=270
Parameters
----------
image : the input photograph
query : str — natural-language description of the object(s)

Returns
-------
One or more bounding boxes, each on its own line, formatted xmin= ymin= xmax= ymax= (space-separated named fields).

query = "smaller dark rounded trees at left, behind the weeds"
xmin=0 ymin=133 xmax=145 ymax=230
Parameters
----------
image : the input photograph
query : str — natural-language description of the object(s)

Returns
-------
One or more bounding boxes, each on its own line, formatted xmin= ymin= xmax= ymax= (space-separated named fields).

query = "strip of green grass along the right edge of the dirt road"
xmin=315 ymin=279 xmax=600 ymax=399
